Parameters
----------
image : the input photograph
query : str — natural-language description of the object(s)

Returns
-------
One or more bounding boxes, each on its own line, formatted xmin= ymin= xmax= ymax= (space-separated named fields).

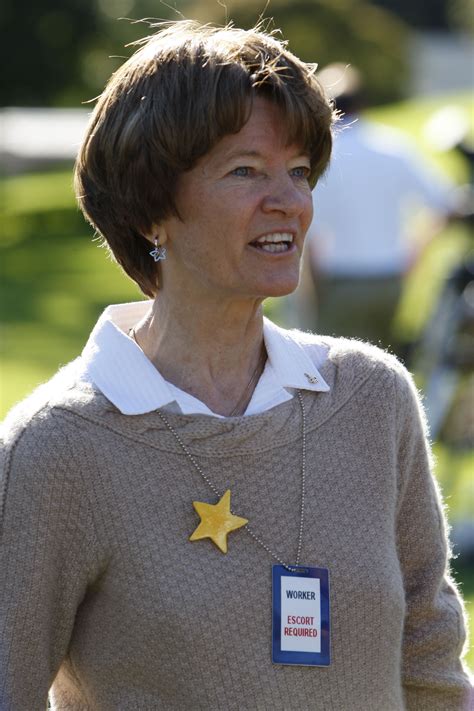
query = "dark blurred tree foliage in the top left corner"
xmin=0 ymin=0 xmax=187 ymax=107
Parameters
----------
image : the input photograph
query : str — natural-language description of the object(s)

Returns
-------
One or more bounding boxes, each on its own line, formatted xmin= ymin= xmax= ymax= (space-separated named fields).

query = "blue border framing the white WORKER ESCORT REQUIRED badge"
xmin=272 ymin=565 xmax=331 ymax=667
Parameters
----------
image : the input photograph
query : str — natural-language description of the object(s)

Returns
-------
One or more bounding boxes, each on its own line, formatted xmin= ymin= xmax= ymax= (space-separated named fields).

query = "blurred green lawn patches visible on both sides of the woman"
xmin=0 ymin=95 xmax=474 ymax=669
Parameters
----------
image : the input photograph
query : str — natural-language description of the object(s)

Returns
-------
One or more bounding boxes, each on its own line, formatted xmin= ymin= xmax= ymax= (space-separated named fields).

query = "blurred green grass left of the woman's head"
xmin=0 ymin=177 xmax=140 ymax=415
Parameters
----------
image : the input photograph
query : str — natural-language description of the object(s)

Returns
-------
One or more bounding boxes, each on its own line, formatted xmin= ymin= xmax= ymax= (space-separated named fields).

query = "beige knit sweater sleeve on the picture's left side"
xmin=0 ymin=413 xmax=105 ymax=711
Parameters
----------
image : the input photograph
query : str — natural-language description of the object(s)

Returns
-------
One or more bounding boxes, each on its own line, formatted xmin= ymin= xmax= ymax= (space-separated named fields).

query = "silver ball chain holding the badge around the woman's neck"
xmin=156 ymin=390 xmax=306 ymax=572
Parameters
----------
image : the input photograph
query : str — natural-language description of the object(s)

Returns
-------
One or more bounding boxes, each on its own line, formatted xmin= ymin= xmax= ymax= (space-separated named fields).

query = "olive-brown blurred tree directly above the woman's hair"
xmin=193 ymin=0 xmax=409 ymax=104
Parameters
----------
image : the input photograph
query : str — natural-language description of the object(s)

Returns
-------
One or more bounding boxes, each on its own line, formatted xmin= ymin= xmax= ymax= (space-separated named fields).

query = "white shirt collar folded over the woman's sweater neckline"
xmin=81 ymin=301 xmax=329 ymax=417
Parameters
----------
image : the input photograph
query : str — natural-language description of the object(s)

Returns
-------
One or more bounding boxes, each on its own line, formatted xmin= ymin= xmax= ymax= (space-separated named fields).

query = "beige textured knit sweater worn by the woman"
xmin=0 ymin=341 xmax=469 ymax=711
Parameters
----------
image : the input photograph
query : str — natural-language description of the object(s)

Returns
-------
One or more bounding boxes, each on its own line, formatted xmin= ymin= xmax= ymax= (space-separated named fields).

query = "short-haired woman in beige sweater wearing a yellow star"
xmin=0 ymin=22 xmax=468 ymax=711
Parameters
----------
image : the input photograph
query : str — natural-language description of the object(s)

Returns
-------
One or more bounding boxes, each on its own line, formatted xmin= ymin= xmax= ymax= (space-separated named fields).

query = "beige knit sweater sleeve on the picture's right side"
xmin=397 ymin=372 xmax=470 ymax=711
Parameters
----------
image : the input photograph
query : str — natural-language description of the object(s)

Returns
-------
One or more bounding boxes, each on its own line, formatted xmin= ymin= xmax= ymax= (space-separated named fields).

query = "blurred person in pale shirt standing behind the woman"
xmin=305 ymin=63 xmax=456 ymax=350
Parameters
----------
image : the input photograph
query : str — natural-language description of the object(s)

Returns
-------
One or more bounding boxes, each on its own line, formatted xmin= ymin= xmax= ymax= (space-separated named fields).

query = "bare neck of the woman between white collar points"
xmin=135 ymin=294 xmax=265 ymax=416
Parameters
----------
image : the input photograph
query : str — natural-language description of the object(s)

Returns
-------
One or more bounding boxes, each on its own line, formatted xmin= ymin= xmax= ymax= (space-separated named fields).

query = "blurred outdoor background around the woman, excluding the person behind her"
xmin=0 ymin=0 xmax=474 ymax=668
